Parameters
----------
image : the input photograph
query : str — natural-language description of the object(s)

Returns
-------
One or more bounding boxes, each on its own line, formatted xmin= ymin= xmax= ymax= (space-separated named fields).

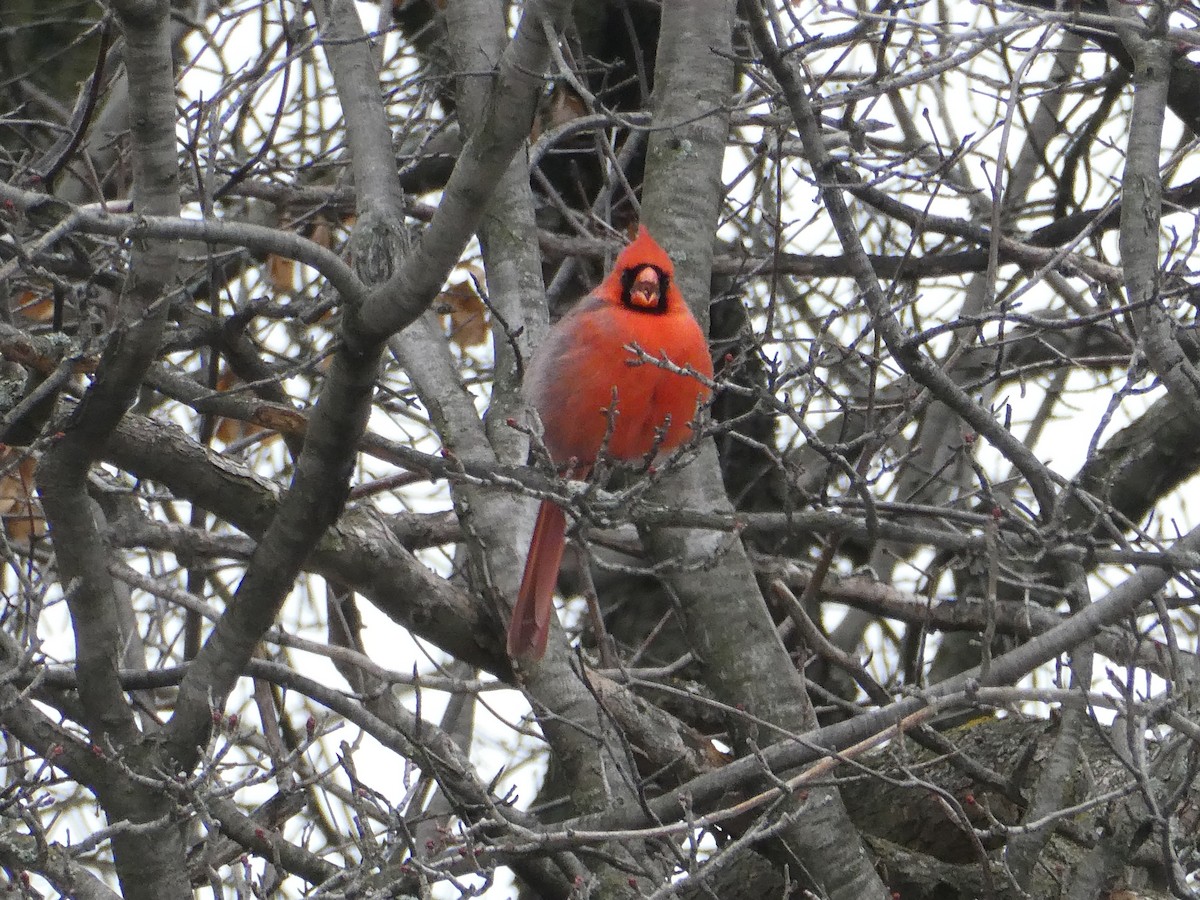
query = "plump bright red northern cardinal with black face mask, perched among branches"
xmin=509 ymin=227 xmax=713 ymax=660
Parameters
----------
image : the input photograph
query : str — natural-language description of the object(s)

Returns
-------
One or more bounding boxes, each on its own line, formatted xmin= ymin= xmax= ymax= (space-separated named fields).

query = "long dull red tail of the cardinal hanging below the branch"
xmin=509 ymin=500 xmax=566 ymax=660
